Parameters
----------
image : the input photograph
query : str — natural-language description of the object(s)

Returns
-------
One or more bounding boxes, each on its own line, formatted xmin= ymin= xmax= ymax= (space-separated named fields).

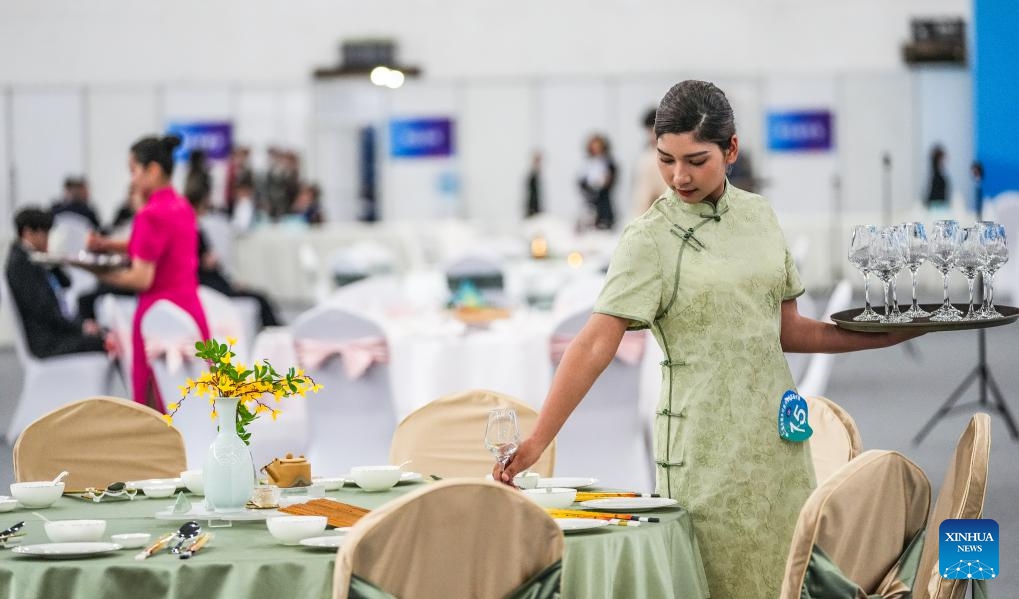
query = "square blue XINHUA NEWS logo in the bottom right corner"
xmin=937 ymin=520 xmax=1000 ymax=581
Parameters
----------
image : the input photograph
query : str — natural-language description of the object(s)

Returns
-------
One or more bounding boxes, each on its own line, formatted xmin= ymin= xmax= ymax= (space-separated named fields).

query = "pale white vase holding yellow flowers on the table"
xmin=202 ymin=397 xmax=255 ymax=511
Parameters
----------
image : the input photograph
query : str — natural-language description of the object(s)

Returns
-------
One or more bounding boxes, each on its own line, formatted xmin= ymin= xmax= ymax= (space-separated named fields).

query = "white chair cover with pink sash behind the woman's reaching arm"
xmin=552 ymin=307 xmax=654 ymax=491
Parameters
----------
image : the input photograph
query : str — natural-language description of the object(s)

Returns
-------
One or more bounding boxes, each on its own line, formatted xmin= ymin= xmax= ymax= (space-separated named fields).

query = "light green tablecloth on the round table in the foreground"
xmin=0 ymin=483 xmax=708 ymax=599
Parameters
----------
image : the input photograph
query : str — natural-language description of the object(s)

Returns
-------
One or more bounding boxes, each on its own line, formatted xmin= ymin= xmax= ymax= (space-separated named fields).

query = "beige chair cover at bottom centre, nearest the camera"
xmin=332 ymin=479 xmax=562 ymax=599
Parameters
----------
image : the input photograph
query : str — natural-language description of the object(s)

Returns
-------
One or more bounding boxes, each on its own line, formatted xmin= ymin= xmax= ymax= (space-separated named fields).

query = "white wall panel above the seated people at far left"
xmin=11 ymin=88 xmax=86 ymax=206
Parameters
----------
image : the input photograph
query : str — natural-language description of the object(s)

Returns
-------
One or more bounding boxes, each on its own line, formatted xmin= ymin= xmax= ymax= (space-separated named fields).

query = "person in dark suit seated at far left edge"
xmin=7 ymin=208 xmax=106 ymax=358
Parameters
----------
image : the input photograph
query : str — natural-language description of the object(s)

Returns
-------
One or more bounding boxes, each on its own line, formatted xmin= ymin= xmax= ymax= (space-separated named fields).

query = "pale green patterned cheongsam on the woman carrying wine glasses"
xmin=594 ymin=182 xmax=815 ymax=599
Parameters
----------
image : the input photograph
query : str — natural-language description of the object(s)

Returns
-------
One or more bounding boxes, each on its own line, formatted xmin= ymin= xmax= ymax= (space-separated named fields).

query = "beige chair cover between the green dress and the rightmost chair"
xmin=782 ymin=450 xmax=930 ymax=599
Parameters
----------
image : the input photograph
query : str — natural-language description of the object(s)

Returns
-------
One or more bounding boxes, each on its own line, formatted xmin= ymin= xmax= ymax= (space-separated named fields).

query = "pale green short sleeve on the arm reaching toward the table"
xmin=594 ymin=226 xmax=662 ymax=330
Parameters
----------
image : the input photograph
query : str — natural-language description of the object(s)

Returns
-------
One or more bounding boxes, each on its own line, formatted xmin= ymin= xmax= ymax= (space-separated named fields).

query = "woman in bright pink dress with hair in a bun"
xmin=96 ymin=137 xmax=209 ymax=411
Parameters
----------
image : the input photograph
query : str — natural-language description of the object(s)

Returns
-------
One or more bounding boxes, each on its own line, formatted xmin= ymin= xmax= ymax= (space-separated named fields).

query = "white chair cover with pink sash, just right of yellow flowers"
xmin=291 ymin=306 xmax=396 ymax=476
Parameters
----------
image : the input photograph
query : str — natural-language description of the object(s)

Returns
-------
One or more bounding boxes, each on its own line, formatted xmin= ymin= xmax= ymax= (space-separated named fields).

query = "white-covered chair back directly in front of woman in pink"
xmin=142 ymin=300 xmax=210 ymax=469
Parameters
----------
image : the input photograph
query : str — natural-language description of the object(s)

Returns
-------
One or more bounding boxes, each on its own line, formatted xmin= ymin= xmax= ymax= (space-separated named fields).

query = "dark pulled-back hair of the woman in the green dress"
xmin=654 ymin=79 xmax=736 ymax=152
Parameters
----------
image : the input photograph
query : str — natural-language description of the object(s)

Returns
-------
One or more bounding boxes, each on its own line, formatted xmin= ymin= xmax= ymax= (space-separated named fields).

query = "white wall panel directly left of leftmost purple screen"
xmin=86 ymin=88 xmax=158 ymax=223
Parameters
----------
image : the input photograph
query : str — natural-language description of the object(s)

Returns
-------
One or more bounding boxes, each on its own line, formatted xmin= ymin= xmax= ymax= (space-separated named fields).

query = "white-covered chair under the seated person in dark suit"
xmin=0 ymin=276 xmax=115 ymax=444
